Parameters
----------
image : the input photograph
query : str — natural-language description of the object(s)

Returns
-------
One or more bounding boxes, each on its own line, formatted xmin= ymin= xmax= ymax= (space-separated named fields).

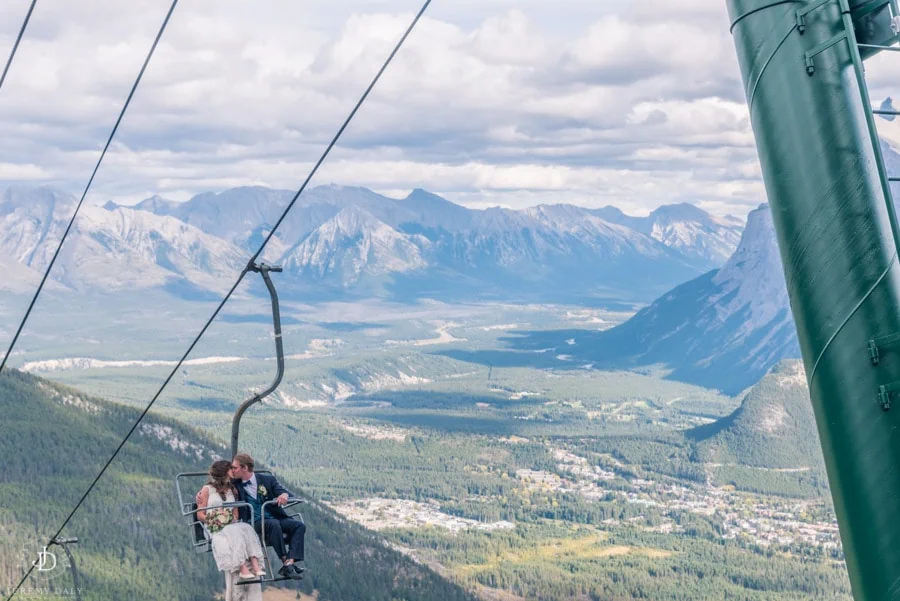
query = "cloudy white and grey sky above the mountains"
xmin=0 ymin=0 xmax=900 ymax=216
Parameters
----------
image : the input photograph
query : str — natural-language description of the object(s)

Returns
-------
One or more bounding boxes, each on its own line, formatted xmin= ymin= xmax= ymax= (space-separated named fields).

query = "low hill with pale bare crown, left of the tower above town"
xmin=689 ymin=359 xmax=825 ymax=474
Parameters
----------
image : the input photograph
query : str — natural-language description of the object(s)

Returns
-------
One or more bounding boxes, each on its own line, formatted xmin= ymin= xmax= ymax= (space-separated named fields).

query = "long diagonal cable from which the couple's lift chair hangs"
xmin=6 ymin=0 xmax=432 ymax=601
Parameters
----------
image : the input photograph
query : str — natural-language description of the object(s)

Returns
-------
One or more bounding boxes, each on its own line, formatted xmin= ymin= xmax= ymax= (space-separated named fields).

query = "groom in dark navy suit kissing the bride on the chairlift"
xmin=231 ymin=453 xmax=306 ymax=580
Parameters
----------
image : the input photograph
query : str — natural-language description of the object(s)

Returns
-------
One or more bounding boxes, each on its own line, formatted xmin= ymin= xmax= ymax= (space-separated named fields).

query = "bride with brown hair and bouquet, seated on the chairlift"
xmin=197 ymin=460 xmax=266 ymax=580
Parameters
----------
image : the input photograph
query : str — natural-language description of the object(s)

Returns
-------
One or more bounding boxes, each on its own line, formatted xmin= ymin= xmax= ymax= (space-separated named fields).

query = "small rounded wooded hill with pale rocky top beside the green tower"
xmin=688 ymin=360 xmax=827 ymax=496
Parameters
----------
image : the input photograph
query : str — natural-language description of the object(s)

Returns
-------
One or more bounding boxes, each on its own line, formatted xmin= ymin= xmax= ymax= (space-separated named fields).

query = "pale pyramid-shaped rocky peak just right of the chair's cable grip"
xmin=283 ymin=206 xmax=429 ymax=287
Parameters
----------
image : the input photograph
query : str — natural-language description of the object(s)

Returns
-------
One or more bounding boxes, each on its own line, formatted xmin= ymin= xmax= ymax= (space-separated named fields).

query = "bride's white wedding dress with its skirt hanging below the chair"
xmin=204 ymin=485 xmax=265 ymax=601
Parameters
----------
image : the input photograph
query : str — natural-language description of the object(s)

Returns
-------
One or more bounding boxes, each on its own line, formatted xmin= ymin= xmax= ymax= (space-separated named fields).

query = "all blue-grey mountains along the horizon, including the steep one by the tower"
xmin=0 ymin=137 xmax=900 ymax=394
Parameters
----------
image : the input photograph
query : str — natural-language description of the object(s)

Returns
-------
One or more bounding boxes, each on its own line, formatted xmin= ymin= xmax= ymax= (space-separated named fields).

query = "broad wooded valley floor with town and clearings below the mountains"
xmin=19 ymin=305 xmax=850 ymax=601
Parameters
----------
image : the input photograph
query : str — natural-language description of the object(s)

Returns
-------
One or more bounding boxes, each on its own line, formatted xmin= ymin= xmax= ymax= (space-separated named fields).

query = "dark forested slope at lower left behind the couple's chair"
xmin=0 ymin=372 xmax=471 ymax=601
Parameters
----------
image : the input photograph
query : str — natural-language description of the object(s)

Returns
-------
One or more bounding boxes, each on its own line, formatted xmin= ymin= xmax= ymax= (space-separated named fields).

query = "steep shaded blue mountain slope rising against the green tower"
xmin=597 ymin=205 xmax=800 ymax=393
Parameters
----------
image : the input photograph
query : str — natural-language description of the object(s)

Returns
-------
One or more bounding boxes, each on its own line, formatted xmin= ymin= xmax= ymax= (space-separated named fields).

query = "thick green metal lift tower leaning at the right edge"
xmin=726 ymin=0 xmax=900 ymax=601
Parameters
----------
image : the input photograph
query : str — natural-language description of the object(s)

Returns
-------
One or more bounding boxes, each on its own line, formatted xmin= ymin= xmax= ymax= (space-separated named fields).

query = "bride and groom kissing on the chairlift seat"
xmin=197 ymin=453 xmax=306 ymax=580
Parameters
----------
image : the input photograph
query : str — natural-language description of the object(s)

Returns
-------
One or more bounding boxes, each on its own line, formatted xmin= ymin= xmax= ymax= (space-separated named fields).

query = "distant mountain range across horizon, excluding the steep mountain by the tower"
xmin=0 ymin=186 xmax=742 ymax=302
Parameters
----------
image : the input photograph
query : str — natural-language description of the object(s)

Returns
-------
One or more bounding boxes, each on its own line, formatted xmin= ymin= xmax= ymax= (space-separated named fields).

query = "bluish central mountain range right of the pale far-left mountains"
xmin=96 ymin=186 xmax=736 ymax=301
